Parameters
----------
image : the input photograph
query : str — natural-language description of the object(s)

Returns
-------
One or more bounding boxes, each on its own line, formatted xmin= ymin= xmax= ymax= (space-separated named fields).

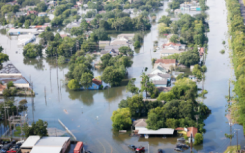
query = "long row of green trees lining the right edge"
xmin=226 ymin=0 xmax=245 ymax=131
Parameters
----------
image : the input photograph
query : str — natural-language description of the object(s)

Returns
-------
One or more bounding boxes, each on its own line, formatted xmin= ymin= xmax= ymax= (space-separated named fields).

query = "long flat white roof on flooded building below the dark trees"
xmin=138 ymin=128 xmax=174 ymax=135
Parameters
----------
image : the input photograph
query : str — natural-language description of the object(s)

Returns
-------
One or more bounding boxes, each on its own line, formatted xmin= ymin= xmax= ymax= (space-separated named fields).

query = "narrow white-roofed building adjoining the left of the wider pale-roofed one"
xmin=20 ymin=136 xmax=41 ymax=153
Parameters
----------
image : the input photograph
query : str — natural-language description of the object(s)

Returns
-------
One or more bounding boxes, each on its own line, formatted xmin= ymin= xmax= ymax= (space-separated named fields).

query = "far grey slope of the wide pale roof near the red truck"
xmin=35 ymin=137 xmax=70 ymax=147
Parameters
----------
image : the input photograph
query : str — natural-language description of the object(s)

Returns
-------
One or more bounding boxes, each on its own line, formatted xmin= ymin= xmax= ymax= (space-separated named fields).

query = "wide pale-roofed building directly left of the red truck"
xmin=30 ymin=137 xmax=71 ymax=153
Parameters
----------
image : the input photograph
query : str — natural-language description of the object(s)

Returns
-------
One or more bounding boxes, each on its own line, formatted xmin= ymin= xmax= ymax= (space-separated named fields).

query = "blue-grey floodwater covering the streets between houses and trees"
xmin=0 ymin=0 xmax=244 ymax=153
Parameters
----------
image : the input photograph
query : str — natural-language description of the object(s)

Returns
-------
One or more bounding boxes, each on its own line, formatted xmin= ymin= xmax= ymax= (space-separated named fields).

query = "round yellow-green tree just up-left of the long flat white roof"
xmin=111 ymin=108 xmax=132 ymax=130
